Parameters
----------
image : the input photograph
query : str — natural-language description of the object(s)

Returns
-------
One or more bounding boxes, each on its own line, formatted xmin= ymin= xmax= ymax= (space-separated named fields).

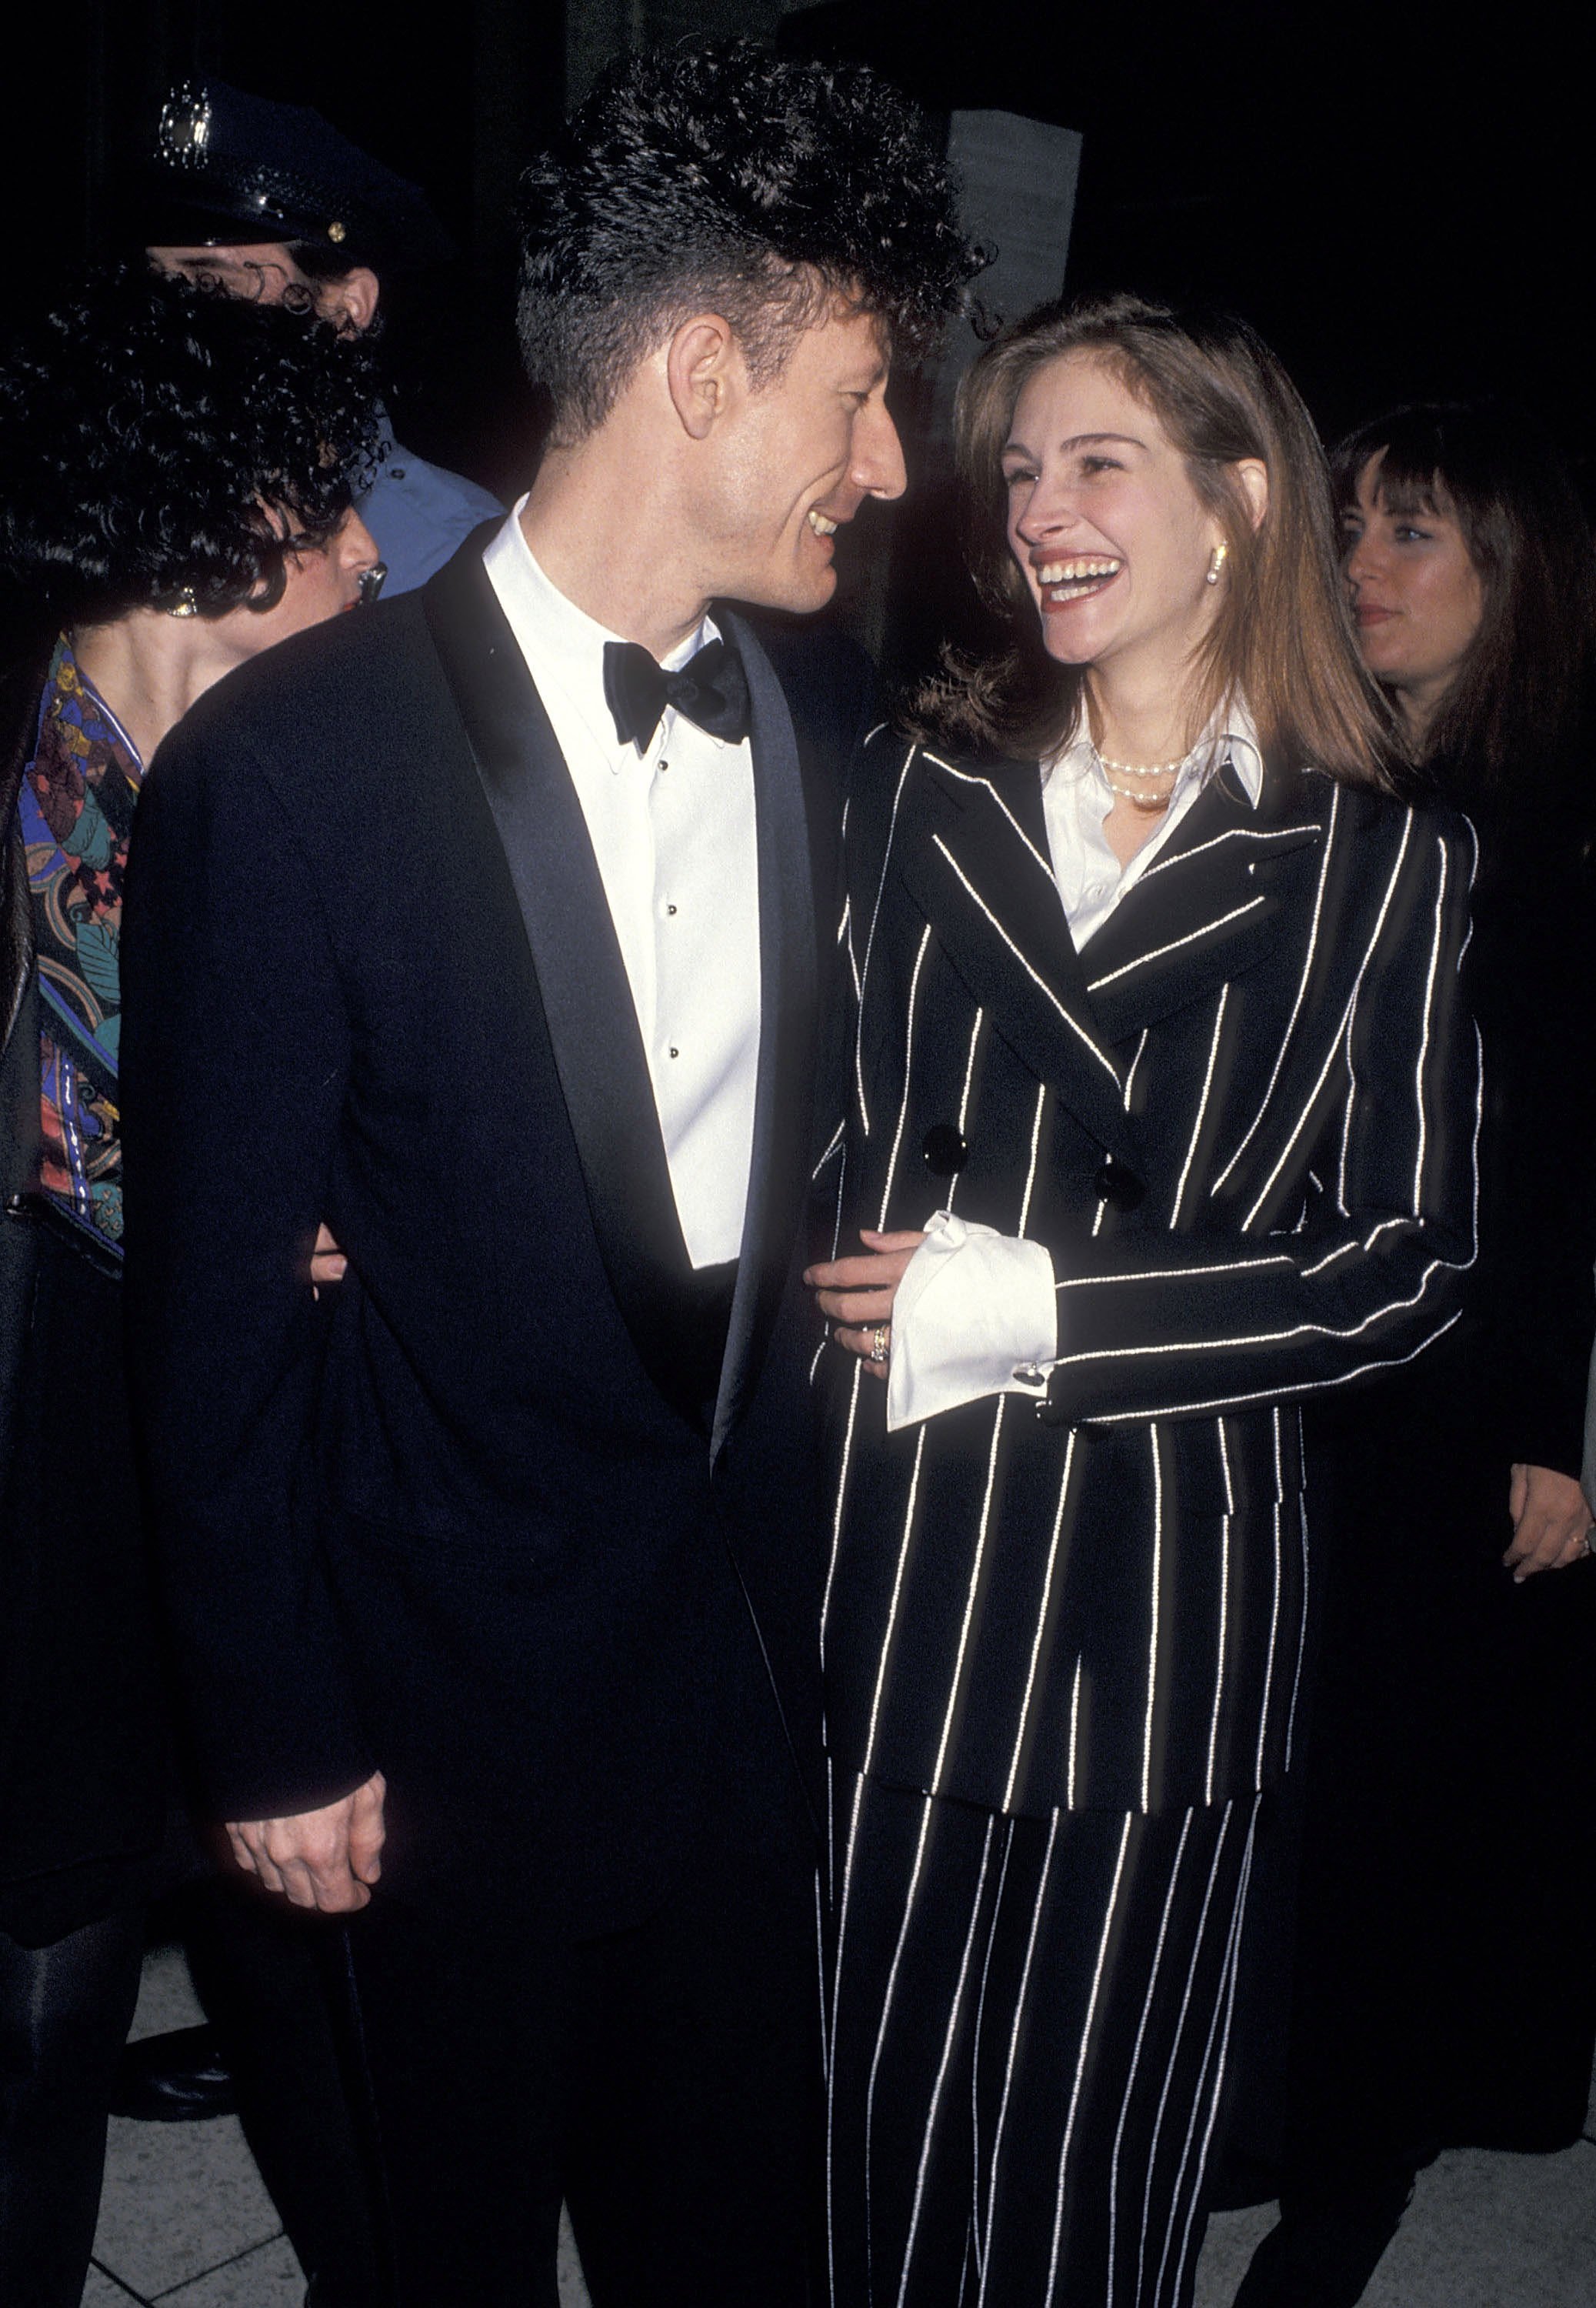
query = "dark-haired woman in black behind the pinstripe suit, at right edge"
xmin=1241 ymin=406 xmax=1596 ymax=2308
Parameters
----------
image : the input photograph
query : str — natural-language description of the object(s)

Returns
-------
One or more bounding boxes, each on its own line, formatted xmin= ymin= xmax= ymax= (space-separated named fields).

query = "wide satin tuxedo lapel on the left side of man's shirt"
xmin=425 ymin=540 xmax=699 ymax=1417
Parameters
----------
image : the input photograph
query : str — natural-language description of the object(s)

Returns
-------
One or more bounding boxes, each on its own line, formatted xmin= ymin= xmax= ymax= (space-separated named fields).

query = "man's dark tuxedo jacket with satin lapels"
xmin=122 ymin=535 xmax=867 ymax=1918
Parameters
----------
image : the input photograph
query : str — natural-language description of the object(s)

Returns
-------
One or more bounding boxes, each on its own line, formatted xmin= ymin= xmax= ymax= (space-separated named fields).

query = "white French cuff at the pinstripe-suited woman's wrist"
xmin=885 ymin=1209 xmax=1058 ymax=1431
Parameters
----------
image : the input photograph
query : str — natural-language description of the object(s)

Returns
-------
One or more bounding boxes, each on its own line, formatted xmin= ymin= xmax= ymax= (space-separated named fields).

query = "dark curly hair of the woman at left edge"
xmin=0 ymin=265 xmax=378 ymax=625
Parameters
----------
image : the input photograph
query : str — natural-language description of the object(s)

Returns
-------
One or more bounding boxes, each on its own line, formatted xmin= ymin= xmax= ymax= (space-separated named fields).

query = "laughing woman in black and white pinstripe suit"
xmin=809 ymin=298 xmax=1476 ymax=2308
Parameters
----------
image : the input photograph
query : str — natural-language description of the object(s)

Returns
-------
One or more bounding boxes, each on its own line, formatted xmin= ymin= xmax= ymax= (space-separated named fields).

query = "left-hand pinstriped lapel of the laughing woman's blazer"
xmin=899 ymin=755 xmax=1135 ymax=1161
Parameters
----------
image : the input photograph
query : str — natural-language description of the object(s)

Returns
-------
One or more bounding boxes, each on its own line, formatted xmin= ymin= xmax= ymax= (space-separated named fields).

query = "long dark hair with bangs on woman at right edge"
xmin=1331 ymin=402 xmax=1596 ymax=815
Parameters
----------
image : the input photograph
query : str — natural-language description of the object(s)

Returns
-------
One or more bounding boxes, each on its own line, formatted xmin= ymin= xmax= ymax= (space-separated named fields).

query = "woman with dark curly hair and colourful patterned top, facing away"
xmin=0 ymin=270 xmax=376 ymax=2308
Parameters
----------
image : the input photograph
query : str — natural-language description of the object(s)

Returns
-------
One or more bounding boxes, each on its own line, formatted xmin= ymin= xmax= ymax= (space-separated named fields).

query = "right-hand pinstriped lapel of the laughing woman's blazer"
xmin=1081 ymin=764 xmax=1321 ymax=1041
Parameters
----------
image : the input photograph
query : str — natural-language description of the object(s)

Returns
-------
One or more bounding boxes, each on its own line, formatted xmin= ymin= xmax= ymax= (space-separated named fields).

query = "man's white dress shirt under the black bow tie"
xmin=482 ymin=499 xmax=759 ymax=1267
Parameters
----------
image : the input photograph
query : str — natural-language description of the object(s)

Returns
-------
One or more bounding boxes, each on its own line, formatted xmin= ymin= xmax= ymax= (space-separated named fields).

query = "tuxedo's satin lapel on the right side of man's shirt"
xmin=711 ymin=607 xmax=816 ymax=1456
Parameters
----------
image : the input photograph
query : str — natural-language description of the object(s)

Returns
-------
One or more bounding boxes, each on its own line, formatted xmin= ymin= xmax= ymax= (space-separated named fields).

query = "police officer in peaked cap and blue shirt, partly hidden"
xmin=143 ymin=81 xmax=503 ymax=593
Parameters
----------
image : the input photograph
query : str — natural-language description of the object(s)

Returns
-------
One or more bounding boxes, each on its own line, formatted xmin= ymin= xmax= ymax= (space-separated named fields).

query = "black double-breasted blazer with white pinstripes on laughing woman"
xmin=818 ymin=732 xmax=1478 ymax=1812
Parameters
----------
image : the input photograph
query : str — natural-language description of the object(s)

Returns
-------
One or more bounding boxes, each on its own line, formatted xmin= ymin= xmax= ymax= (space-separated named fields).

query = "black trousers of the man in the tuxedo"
xmin=346 ymin=1749 xmax=821 ymax=2308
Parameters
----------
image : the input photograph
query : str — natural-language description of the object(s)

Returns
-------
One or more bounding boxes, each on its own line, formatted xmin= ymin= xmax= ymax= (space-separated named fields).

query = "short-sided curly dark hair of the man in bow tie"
xmin=519 ymin=42 xmax=982 ymax=441
